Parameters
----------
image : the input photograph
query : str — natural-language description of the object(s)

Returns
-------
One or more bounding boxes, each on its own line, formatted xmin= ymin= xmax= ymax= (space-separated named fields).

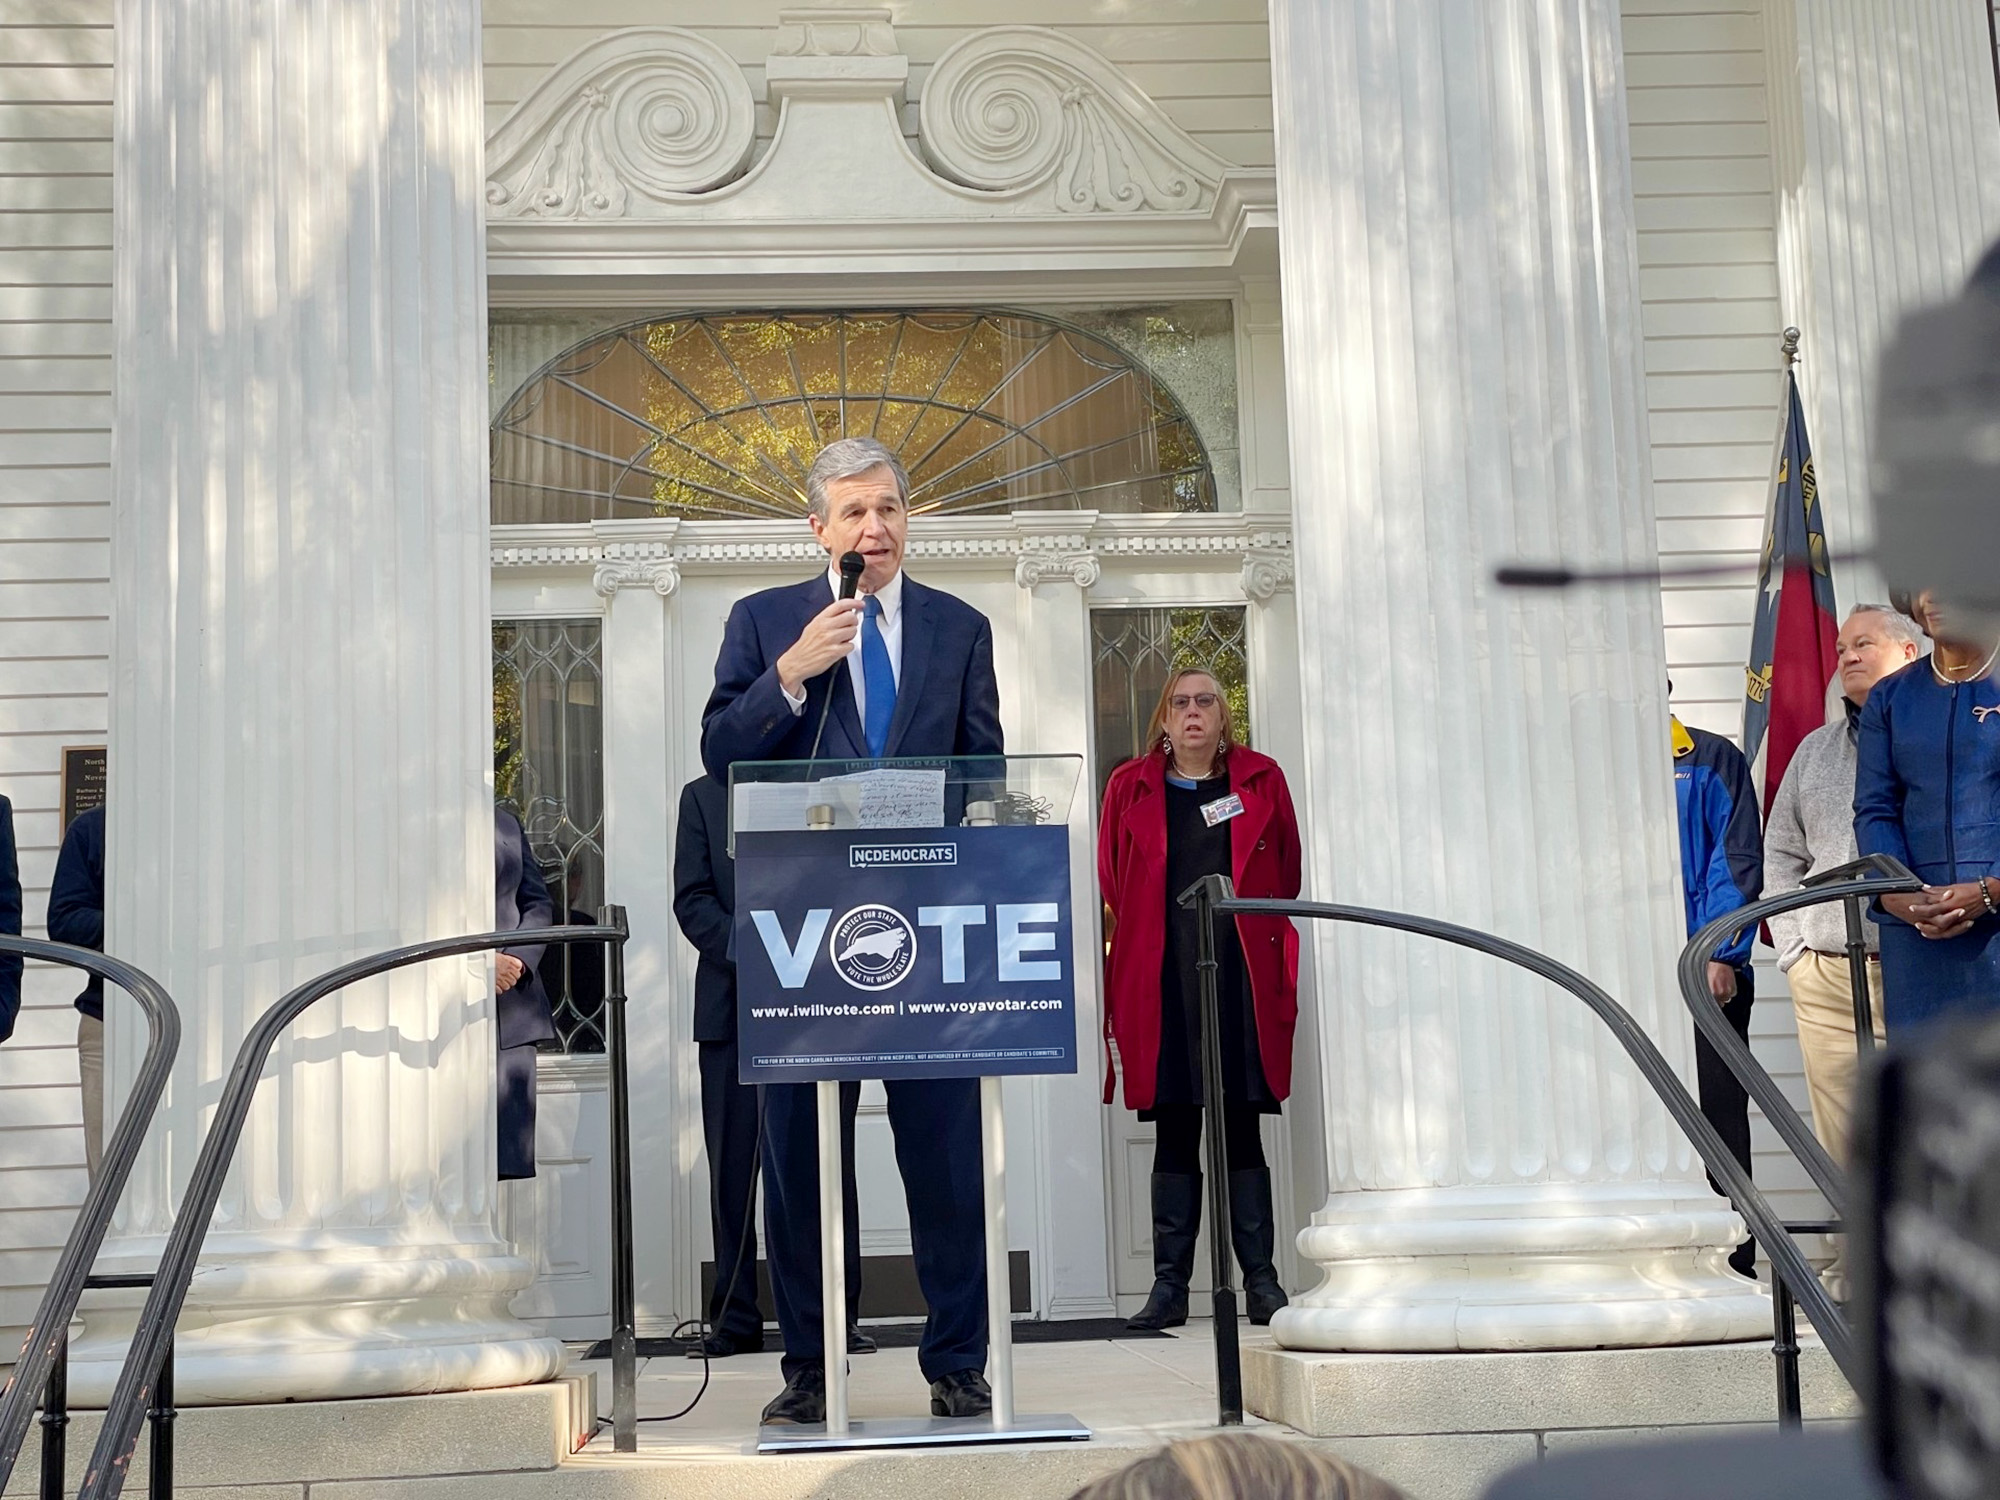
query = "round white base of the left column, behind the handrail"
xmin=70 ymin=1234 xmax=564 ymax=1408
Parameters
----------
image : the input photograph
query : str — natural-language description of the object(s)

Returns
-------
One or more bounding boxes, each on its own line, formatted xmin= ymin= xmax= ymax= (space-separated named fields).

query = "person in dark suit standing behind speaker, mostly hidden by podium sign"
xmin=674 ymin=776 xmax=874 ymax=1360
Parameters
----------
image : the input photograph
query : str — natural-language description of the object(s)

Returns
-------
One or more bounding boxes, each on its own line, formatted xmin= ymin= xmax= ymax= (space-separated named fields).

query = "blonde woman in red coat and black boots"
xmin=1098 ymin=672 xmax=1298 ymax=1328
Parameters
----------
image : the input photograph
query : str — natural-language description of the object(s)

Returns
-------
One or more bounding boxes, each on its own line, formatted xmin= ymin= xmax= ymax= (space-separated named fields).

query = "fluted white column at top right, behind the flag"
xmin=1764 ymin=0 xmax=2000 ymax=602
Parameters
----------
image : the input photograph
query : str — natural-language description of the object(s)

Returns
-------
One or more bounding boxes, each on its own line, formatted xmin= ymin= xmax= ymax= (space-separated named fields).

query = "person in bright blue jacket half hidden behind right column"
xmin=1666 ymin=696 xmax=1764 ymax=1276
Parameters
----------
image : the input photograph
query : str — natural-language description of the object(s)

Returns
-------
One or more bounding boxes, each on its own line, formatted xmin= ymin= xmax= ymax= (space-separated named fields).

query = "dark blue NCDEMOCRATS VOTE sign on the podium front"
xmin=736 ymin=826 xmax=1076 ymax=1084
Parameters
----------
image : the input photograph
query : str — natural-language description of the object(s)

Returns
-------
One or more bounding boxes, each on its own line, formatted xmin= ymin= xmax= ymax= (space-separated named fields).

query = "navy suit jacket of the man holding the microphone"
xmin=702 ymin=572 xmax=1004 ymax=786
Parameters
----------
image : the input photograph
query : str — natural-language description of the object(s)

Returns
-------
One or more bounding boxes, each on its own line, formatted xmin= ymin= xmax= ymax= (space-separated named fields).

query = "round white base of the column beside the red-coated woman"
xmin=1270 ymin=1184 xmax=1770 ymax=1352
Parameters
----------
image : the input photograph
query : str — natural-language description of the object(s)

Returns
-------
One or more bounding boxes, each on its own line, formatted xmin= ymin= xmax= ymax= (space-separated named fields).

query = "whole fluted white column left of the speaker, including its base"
xmin=72 ymin=0 xmax=562 ymax=1402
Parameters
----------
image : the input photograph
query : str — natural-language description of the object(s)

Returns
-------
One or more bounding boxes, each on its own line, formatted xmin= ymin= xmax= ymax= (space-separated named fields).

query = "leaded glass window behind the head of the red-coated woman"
xmin=1090 ymin=604 xmax=1250 ymax=788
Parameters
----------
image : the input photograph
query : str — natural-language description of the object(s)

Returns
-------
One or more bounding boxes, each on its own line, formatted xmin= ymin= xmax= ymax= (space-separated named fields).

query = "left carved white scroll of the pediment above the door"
xmin=486 ymin=26 xmax=756 ymax=220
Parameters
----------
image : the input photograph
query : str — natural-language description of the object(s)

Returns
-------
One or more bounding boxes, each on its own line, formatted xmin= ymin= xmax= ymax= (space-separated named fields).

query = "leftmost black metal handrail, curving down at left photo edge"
xmin=0 ymin=934 xmax=180 ymax=1490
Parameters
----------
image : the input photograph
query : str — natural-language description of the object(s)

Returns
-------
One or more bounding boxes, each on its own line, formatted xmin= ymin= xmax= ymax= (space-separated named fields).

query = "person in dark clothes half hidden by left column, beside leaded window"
xmin=494 ymin=808 xmax=556 ymax=1182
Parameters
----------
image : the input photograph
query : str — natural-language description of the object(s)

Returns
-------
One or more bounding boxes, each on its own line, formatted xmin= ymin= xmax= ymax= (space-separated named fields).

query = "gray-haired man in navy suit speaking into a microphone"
xmin=702 ymin=438 xmax=1002 ymax=1422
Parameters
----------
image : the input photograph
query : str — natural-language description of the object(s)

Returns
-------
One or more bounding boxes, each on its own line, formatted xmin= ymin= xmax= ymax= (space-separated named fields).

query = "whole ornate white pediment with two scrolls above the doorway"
xmin=486 ymin=8 xmax=1276 ymax=276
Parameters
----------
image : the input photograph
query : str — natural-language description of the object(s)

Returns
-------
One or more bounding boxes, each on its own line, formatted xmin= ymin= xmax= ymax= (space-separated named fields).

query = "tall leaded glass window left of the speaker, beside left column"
xmin=494 ymin=620 xmax=604 ymax=1052
